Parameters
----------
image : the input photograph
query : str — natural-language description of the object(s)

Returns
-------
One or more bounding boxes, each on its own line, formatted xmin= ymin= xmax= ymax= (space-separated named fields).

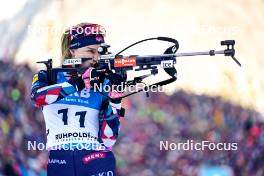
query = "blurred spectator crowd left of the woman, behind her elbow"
xmin=0 ymin=61 xmax=47 ymax=176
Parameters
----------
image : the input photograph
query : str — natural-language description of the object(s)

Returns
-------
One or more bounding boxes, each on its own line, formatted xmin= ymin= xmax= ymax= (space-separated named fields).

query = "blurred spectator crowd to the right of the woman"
xmin=115 ymin=91 xmax=264 ymax=176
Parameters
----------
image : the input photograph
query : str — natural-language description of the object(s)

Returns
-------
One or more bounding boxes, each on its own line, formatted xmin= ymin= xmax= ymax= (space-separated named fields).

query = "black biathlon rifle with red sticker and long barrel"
xmin=37 ymin=37 xmax=241 ymax=98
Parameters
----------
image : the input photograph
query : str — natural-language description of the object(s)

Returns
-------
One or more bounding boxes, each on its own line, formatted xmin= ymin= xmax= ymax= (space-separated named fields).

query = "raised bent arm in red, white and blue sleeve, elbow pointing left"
xmin=31 ymin=70 xmax=84 ymax=107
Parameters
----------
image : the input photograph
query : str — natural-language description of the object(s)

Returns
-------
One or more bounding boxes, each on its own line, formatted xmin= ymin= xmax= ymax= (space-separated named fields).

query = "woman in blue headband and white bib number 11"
xmin=31 ymin=23 xmax=122 ymax=176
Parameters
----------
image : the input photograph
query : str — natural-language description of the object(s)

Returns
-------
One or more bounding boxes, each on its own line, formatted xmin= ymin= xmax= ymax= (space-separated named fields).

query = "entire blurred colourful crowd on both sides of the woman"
xmin=0 ymin=61 xmax=264 ymax=176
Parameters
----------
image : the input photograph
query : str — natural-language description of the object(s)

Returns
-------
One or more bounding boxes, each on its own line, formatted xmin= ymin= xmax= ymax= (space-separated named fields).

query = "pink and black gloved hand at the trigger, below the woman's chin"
xmin=82 ymin=67 xmax=104 ymax=89
